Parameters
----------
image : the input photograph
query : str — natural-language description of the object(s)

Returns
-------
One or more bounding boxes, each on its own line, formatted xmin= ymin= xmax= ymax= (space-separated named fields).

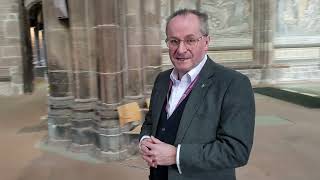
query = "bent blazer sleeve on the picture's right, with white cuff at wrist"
xmin=180 ymin=76 xmax=255 ymax=173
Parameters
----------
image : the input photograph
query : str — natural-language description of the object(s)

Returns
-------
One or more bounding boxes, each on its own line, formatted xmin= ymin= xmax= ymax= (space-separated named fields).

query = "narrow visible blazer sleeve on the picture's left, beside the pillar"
xmin=139 ymin=74 xmax=160 ymax=140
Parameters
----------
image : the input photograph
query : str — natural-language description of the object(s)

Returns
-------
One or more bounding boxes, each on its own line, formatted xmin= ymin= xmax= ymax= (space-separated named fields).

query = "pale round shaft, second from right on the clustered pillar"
xmin=124 ymin=0 xmax=143 ymax=101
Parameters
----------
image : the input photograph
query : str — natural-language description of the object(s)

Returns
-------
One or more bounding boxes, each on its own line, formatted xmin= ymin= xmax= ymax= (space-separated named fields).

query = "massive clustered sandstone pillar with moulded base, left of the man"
xmin=43 ymin=0 xmax=161 ymax=160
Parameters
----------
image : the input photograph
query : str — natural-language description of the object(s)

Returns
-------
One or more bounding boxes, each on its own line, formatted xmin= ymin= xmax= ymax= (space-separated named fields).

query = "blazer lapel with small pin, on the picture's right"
xmin=174 ymin=57 xmax=214 ymax=145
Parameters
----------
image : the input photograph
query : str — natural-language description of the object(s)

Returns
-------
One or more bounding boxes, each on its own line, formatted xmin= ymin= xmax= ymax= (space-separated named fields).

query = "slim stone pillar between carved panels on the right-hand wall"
xmin=253 ymin=0 xmax=276 ymax=81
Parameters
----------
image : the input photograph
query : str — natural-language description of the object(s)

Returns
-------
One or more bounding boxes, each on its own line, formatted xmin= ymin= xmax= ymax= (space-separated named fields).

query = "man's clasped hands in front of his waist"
xmin=139 ymin=136 xmax=177 ymax=168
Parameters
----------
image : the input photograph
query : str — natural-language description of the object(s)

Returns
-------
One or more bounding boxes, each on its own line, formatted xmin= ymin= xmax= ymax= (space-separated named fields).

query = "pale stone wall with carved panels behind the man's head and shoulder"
xmin=161 ymin=0 xmax=320 ymax=85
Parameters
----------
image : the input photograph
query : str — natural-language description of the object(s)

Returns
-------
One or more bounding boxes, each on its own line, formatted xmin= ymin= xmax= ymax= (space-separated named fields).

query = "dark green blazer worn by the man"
xmin=140 ymin=57 xmax=255 ymax=180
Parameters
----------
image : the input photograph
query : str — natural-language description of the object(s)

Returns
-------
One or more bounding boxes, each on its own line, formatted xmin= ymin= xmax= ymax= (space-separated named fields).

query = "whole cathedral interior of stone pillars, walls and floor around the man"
xmin=0 ymin=0 xmax=320 ymax=180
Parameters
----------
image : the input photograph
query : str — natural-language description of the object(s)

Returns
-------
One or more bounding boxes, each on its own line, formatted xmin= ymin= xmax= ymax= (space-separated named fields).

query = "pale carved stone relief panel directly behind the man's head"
xmin=161 ymin=0 xmax=252 ymax=47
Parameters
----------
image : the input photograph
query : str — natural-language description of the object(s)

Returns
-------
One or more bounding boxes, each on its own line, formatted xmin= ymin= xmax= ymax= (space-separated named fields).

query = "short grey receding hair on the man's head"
xmin=166 ymin=9 xmax=209 ymax=36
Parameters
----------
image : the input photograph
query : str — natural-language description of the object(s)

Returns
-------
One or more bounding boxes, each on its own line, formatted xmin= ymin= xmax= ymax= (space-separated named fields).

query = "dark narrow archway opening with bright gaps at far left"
xmin=19 ymin=0 xmax=47 ymax=93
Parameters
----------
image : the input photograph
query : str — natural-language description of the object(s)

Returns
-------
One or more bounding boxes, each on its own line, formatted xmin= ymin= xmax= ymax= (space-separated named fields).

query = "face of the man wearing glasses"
xmin=167 ymin=14 xmax=209 ymax=75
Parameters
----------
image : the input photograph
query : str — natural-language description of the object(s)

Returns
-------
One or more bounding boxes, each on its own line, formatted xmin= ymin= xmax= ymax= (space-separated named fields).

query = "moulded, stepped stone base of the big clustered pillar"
xmin=48 ymin=97 xmax=138 ymax=161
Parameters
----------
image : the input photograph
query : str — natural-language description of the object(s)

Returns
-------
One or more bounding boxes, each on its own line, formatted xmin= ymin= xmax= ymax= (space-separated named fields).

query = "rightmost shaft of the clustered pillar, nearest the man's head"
xmin=142 ymin=0 xmax=162 ymax=96
